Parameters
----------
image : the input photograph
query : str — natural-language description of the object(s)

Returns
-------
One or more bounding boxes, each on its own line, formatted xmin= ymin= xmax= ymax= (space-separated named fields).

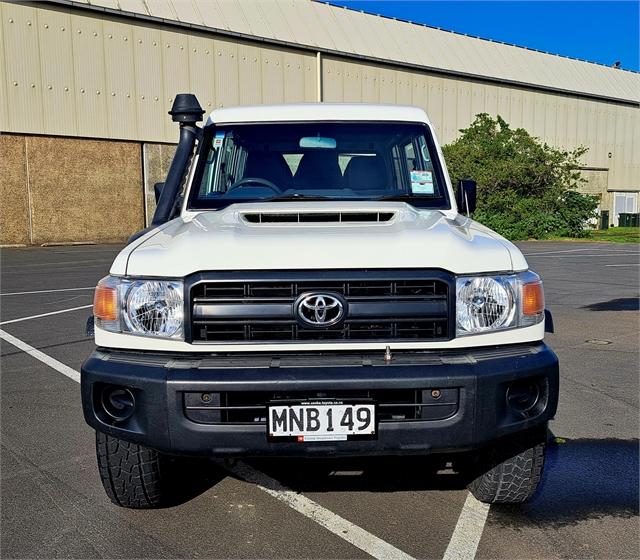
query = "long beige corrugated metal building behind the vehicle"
xmin=0 ymin=0 xmax=640 ymax=244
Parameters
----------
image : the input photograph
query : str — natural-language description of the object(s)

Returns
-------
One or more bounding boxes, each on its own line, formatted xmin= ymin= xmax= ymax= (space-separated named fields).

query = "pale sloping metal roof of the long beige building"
xmin=45 ymin=0 xmax=640 ymax=103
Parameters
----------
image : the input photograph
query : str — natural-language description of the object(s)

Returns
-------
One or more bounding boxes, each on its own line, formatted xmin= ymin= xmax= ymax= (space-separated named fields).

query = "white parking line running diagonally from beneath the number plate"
xmin=220 ymin=461 xmax=413 ymax=560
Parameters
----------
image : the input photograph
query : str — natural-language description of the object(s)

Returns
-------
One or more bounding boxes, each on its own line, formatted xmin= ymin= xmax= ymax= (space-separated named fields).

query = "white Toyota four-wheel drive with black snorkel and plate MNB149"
xmin=82 ymin=94 xmax=558 ymax=508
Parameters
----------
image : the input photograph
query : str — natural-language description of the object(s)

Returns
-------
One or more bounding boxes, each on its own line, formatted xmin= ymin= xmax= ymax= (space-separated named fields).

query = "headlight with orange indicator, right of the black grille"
xmin=456 ymin=271 xmax=544 ymax=336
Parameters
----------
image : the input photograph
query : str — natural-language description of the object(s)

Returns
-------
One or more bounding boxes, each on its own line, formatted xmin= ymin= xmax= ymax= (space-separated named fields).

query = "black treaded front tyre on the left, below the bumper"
xmin=96 ymin=432 xmax=166 ymax=509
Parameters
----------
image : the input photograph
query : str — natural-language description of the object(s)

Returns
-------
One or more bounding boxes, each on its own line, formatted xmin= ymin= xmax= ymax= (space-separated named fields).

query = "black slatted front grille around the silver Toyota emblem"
xmin=191 ymin=277 xmax=450 ymax=342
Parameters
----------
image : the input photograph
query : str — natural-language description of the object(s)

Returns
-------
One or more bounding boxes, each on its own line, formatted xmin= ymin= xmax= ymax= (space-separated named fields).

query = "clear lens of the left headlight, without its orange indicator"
xmin=124 ymin=280 xmax=184 ymax=337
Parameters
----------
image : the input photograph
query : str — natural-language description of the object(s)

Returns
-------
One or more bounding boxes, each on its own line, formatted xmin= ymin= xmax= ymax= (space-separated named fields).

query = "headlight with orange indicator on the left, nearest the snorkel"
xmin=94 ymin=276 xmax=184 ymax=338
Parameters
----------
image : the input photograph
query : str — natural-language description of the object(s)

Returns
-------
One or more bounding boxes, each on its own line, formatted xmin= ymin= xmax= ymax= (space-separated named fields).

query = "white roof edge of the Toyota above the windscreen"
xmin=209 ymin=103 xmax=429 ymax=124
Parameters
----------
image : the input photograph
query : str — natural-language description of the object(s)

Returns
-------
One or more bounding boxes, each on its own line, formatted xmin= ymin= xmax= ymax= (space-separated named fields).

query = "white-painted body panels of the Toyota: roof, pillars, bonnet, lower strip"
xmin=96 ymin=104 xmax=544 ymax=352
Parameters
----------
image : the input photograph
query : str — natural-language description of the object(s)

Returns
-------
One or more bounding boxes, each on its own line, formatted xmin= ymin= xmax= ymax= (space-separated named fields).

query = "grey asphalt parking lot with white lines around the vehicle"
xmin=0 ymin=242 xmax=640 ymax=559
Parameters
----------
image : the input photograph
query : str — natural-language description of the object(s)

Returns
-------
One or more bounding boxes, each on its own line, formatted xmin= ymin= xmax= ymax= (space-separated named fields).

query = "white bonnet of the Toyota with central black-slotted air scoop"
xmin=111 ymin=201 xmax=527 ymax=278
